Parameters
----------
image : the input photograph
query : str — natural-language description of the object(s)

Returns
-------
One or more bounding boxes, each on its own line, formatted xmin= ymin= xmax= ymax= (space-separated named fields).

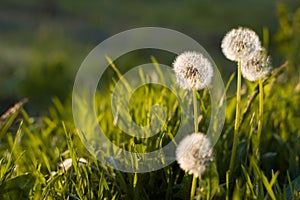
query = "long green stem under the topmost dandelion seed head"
xmin=229 ymin=60 xmax=242 ymax=174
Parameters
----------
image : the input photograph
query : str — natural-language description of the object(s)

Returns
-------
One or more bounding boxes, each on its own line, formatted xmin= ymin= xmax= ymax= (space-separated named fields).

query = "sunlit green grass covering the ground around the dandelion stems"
xmin=0 ymin=55 xmax=300 ymax=199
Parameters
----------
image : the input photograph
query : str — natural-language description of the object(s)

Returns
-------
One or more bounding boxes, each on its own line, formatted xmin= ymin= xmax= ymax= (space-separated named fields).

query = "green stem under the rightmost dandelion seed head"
xmin=256 ymin=79 xmax=264 ymax=160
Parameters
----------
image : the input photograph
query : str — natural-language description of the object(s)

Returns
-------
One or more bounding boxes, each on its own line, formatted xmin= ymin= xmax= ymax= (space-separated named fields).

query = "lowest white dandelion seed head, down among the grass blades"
xmin=176 ymin=133 xmax=214 ymax=177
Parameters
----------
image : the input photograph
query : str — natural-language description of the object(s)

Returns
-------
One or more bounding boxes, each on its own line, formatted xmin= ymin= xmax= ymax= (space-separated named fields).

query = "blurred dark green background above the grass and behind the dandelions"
xmin=0 ymin=0 xmax=300 ymax=114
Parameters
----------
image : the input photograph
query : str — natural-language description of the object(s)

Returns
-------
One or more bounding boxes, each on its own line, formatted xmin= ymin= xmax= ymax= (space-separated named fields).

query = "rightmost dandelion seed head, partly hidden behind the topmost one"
xmin=241 ymin=48 xmax=272 ymax=81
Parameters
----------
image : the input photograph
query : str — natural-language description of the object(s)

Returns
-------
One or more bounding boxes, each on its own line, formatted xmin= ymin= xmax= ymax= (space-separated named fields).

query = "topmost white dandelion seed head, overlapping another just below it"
xmin=221 ymin=27 xmax=261 ymax=61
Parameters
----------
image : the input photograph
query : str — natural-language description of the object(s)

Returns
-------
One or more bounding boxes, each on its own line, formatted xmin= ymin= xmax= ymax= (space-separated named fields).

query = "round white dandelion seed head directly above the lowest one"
xmin=173 ymin=51 xmax=213 ymax=90
